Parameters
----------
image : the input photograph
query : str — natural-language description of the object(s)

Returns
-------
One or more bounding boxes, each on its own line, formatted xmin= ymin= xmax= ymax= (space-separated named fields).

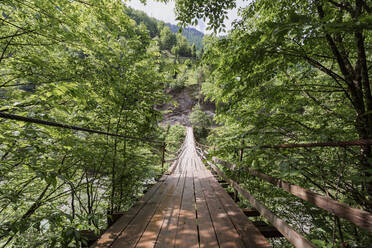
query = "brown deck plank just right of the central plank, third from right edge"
xmin=194 ymin=159 xmax=219 ymax=248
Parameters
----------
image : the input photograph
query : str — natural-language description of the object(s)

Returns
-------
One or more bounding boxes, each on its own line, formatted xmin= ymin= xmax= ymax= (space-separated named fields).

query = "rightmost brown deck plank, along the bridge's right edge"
xmin=206 ymin=168 xmax=271 ymax=248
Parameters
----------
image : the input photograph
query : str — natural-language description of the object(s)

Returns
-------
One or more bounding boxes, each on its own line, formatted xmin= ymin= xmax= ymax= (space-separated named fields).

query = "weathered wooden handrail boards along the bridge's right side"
xmin=197 ymin=142 xmax=372 ymax=247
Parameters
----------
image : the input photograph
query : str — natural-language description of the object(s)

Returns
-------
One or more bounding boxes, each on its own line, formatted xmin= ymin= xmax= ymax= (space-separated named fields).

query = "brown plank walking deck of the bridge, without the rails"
xmin=92 ymin=128 xmax=270 ymax=248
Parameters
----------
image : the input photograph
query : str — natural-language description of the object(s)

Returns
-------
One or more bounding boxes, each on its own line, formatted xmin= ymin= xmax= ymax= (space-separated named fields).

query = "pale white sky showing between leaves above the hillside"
xmin=125 ymin=0 xmax=248 ymax=33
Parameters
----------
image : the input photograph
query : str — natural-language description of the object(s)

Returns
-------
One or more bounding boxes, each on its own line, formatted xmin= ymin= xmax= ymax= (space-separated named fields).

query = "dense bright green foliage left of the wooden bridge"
xmin=0 ymin=0 xmax=185 ymax=247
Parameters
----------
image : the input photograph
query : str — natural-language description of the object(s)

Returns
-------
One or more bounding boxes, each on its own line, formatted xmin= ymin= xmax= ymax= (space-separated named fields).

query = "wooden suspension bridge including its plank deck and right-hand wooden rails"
xmin=91 ymin=128 xmax=372 ymax=248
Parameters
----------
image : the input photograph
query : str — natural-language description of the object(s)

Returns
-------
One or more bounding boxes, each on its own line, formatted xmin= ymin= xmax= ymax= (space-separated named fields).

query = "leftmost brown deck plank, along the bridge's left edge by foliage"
xmin=91 ymin=182 xmax=162 ymax=248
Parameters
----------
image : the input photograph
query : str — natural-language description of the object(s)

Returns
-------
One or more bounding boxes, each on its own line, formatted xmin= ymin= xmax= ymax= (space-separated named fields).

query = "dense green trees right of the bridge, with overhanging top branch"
xmin=168 ymin=0 xmax=372 ymax=247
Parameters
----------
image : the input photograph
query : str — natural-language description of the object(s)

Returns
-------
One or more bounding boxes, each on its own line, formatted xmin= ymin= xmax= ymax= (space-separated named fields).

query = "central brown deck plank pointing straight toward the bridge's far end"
xmin=174 ymin=162 xmax=199 ymax=248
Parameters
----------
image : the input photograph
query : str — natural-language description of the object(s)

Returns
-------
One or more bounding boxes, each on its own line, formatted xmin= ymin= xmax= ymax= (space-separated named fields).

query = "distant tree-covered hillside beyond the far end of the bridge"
xmin=126 ymin=8 xmax=215 ymax=126
